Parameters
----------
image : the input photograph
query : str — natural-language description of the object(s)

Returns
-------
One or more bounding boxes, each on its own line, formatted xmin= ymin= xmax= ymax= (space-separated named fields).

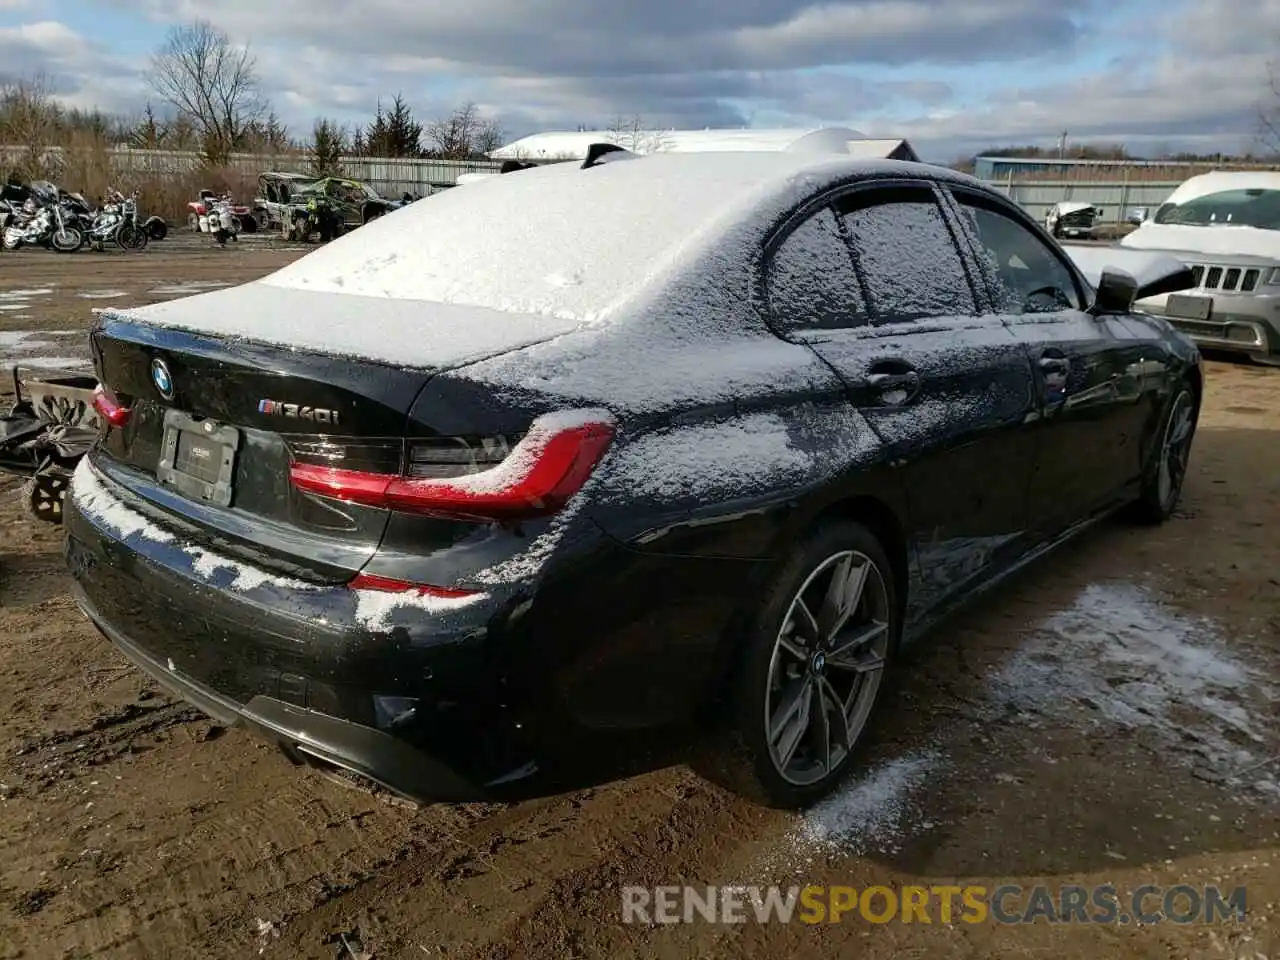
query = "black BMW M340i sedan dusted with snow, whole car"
xmin=65 ymin=152 xmax=1203 ymax=806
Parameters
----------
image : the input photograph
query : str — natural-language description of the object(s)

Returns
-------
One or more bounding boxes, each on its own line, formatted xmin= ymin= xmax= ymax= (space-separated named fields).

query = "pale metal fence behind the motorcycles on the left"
xmin=0 ymin=146 xmax=500 ymax=197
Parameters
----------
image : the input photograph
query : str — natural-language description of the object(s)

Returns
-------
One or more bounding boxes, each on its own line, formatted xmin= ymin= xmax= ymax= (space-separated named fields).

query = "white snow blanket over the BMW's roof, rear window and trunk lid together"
xmin=122 ymin=151 xmax=977 ymax=366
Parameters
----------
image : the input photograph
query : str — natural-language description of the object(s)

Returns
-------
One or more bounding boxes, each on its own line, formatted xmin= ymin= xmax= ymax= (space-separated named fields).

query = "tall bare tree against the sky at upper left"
xmin=146 ymin=20 xmax=266 ymax=166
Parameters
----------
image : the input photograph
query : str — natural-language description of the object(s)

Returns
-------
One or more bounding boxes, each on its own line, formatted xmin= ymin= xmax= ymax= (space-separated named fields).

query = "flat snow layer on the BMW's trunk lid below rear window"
xmin=104 ymin=280 xmax=581 ymax=369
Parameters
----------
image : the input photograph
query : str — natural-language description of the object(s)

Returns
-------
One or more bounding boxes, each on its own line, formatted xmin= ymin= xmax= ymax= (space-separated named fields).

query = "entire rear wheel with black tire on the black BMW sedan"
xmin=704 ymin=521 xmax=901 ymax=809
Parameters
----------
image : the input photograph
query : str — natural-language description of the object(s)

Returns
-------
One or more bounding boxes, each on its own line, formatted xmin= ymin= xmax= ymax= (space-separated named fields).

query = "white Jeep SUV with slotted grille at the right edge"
xmin=1120 ymin=170 xmax=1280 ymax=366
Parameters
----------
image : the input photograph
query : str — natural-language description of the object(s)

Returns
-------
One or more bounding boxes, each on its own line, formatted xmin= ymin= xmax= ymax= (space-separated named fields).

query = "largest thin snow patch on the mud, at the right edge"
xmin=991 ymin=584 xmax=1280 ymax=794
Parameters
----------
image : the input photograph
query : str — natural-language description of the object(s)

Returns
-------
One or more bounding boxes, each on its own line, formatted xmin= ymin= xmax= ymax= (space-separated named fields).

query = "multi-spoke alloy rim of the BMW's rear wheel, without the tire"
xmin=764 ymin=550 xmax=890 ymax=786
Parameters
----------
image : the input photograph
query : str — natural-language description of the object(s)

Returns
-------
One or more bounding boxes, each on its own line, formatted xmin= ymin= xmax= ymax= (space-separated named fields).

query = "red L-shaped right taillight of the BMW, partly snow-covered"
xmin=289 ymin=411 xmax=613 ymax=520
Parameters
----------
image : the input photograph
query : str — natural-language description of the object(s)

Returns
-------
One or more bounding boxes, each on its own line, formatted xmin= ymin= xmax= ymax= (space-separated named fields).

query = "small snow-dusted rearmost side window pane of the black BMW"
xmin=767 ymin=207 xmax=867 ymax=332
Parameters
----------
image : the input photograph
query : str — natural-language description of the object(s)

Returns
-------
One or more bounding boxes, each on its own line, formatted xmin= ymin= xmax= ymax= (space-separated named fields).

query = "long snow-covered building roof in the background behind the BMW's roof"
xmin=489 ymin=127 xmax=916 ymax=161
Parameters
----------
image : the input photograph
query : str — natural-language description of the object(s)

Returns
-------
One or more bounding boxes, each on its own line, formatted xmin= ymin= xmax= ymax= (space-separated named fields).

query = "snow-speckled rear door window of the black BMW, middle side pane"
xmin=838 ymin=187 xmax=978 ymax=323
